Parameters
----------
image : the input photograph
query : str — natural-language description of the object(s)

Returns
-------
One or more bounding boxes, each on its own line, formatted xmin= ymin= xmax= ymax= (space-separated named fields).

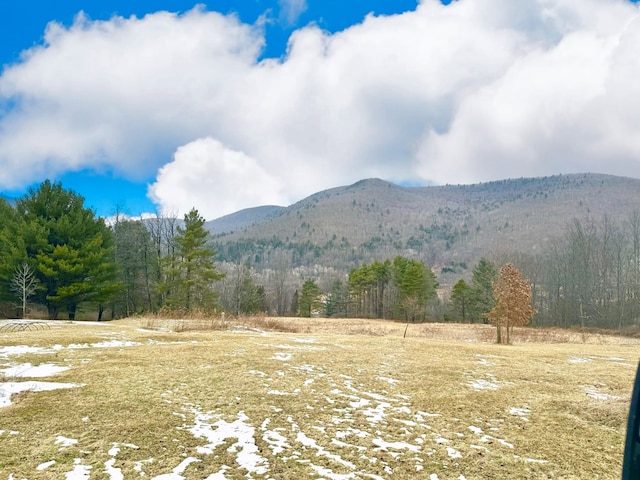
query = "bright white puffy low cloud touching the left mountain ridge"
xmin=149 ymin=138 xmax=285 ymax=219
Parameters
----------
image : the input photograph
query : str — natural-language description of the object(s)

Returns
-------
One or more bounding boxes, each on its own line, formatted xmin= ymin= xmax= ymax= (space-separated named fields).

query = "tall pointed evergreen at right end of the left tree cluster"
xmin=165 ymin=208 xmax=224 ymax=312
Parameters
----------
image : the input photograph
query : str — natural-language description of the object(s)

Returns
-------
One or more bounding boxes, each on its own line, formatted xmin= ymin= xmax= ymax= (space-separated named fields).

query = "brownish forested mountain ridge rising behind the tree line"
xmin=210 ymin=173 xmax=640 ymax=272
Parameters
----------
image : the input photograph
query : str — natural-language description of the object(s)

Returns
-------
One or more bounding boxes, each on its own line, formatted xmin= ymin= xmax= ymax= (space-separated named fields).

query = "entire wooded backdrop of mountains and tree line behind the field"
xmin=0 ymin=174 xmax=640 ymax=334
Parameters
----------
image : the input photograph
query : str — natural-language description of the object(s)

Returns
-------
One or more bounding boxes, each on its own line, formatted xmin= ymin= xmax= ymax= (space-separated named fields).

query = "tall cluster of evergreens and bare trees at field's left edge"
xmin=0 ymin=181 xmax=222 ymax=320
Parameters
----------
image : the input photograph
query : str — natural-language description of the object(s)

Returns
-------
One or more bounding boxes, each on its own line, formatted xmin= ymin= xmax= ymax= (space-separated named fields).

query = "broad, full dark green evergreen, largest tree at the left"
xmin=16 ymin=180 xmax=115 ymax=319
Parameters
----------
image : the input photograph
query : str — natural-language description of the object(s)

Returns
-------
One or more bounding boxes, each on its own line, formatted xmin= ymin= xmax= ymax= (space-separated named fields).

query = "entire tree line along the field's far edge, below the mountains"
xmin=0 ymin=181 xmax=640 ymax=334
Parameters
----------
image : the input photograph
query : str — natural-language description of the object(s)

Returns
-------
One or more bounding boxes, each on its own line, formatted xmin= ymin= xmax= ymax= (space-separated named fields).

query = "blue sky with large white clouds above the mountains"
xmin=0 ymin=0 xmax=640 ymax=220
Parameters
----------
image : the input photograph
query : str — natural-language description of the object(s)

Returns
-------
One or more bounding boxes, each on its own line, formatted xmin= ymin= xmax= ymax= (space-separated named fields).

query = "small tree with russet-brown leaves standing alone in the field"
xmin=486 ymin=263 xmax=536 ymax=343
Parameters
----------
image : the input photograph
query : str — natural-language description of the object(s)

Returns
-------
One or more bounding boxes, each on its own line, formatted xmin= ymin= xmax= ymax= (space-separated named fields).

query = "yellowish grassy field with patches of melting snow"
xmin=0 ymin=319 xmax=640 ymax=480
